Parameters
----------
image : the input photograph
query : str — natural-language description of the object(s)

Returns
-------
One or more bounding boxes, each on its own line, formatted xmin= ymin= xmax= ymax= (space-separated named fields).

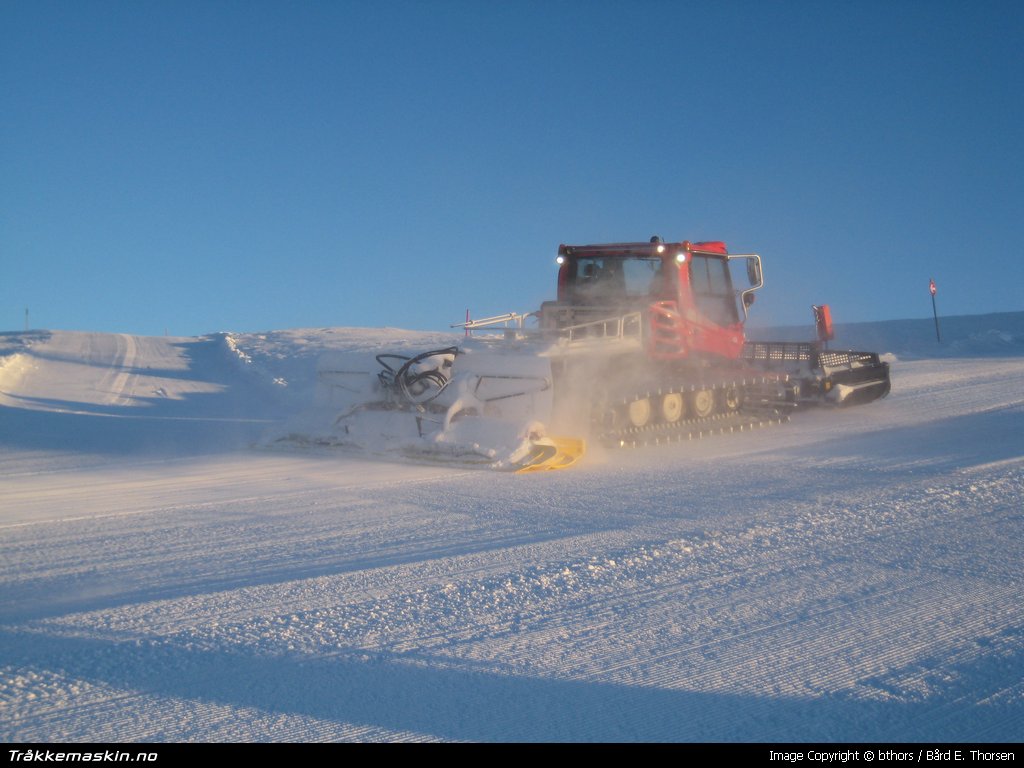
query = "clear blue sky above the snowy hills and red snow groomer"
xmin=0 ymin=0 xmax=1024 ymax=335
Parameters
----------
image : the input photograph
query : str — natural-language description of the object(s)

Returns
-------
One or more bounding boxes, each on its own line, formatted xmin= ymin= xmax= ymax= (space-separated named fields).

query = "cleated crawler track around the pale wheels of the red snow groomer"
xmin=597 ymin=377 xmax=792 ymax=447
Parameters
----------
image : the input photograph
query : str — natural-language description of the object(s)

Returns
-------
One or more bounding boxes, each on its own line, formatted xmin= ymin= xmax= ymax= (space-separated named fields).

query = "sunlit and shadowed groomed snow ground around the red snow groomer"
xmin=0 ymin=313 xmax=1024 ymax=742
